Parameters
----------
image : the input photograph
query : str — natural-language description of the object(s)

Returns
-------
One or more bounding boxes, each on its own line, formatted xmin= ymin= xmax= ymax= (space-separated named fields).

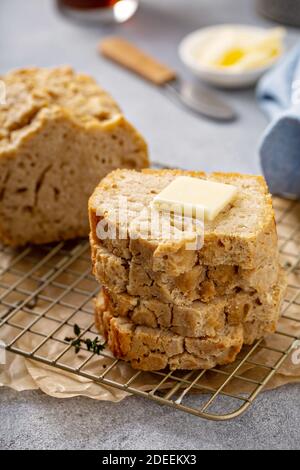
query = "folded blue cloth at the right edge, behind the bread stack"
xmin=257 ymin=46 xmax=300 ymax=198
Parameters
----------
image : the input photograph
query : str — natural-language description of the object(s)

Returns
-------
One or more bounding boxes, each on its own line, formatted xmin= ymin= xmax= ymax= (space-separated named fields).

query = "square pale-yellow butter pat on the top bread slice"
xmin=153 ymin=176 xmax=237 ymax=220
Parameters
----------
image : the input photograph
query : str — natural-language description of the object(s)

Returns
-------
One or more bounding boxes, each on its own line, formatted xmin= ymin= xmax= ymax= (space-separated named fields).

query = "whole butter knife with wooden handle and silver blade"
xmin=99 ymin=37 xmax=236 ymax=121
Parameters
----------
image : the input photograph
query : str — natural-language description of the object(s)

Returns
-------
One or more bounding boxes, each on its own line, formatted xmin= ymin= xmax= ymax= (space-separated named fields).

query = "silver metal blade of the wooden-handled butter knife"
xmin=165 ymin=78 xmax=237 ymax=121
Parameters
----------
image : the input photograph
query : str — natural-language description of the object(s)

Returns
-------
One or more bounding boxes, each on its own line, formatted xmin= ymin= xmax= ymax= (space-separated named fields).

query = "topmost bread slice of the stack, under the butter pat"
xmin=89 ymin=170 xmax=277 ymax=276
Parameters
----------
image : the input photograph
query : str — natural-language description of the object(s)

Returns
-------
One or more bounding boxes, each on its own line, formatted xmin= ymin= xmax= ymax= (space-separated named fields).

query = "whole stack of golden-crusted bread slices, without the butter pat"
xmin=89 ymin=170 xmax=286 ymax=370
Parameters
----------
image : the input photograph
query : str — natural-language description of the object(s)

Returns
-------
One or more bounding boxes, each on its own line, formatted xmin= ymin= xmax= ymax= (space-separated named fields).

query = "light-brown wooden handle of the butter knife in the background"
xmin=99 ymin=37 xmax=176 ymax=85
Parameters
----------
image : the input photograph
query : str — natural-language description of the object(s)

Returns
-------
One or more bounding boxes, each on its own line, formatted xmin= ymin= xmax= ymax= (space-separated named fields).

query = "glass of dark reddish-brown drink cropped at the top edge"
xmin=58 ymin=0 xmax=139 ymax=23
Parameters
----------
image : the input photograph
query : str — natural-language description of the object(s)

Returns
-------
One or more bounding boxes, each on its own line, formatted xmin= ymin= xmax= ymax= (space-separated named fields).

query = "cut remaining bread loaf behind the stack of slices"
xmin=0 ymin=67 xmax=148 ymax=245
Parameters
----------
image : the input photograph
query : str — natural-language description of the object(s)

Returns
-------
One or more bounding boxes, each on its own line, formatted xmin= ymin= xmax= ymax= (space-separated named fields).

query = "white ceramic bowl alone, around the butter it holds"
xmin=179 ymin=24 xmax=282 ymax=88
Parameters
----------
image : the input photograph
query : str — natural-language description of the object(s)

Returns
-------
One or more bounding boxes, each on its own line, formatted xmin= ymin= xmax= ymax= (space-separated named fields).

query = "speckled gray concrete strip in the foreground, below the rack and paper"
xmin=0 ymin=385 xmax=300 ymax=450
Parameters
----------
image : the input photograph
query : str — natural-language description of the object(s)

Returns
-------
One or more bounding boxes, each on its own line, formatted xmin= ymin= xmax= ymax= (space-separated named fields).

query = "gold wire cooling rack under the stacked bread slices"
xmin=0 ymin=193 xmax=300 ymax=421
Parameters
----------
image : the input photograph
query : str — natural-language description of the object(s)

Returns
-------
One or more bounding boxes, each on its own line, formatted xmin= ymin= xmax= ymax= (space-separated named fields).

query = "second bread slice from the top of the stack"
xmin=90 ymin=236 xmax=279 ymax=306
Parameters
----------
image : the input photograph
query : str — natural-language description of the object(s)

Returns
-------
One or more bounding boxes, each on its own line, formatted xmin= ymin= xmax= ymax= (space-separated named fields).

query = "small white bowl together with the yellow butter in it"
xmin=179 ymin=24 xmax=285 ymax=88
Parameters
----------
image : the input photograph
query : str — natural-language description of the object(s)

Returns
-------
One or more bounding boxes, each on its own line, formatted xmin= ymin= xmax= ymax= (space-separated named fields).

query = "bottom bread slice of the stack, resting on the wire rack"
xmin=96 ymin=303 xmax=243 ymax=371
